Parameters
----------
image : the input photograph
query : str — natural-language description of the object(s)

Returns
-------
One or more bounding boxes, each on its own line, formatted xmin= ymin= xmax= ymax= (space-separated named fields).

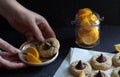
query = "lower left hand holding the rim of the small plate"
xmin=0 ymin=38 xmax=26 ymax=69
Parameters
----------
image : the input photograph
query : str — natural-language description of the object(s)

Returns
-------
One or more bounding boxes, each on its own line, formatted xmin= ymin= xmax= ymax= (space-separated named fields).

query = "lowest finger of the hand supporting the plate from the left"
xmin=0 ymin=56 xmax=25 ymax=69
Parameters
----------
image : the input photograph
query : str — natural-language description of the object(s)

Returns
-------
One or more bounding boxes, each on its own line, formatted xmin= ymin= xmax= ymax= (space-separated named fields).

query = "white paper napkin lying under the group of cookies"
xmin=54 ymin=48 xmax=114 ymax=77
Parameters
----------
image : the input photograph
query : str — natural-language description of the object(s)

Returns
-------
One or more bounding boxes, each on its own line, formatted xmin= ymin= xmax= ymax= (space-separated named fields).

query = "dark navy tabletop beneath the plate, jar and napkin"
xmin=0 ymin=25 xmax=120 ymax=77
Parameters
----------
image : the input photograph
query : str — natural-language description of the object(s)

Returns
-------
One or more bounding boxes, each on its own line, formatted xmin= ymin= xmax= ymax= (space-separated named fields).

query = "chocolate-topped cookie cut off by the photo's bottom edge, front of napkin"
xmin=88 ymin=70 xmax=110 ymax=77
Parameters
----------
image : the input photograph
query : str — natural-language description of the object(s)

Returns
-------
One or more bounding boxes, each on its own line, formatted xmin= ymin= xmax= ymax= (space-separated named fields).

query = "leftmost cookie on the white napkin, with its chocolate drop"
xmin=70 ymin=60 xmax=92 ymax=77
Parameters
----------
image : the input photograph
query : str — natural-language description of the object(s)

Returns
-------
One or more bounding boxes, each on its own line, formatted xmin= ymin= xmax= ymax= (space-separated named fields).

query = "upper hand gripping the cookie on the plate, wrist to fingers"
xmin=8 ymin=10 xmax=55 ymax=41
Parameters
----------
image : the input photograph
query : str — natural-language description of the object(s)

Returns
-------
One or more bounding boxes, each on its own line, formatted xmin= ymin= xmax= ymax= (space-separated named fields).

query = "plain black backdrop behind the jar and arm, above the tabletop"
xmin=0 ymin=0 xmax=120 ymax=47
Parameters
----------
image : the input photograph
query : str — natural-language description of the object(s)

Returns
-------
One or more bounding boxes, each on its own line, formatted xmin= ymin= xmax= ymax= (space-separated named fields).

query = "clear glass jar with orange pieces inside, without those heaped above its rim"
xmin=75 ymin=13 xmax=102 ymax=48
